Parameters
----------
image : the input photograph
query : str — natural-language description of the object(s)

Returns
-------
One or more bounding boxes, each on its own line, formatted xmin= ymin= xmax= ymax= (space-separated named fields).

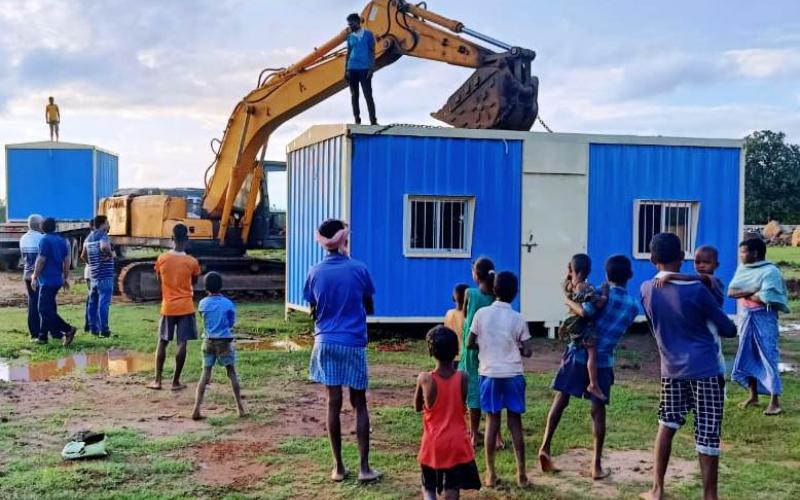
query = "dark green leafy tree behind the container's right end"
xmin=744 ymin=130 xmax=800 ymax=224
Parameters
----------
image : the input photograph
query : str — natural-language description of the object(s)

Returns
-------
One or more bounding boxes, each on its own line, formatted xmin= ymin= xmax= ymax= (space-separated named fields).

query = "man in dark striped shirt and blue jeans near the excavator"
xmin=82 ymin=215 xmax=114 ymax=337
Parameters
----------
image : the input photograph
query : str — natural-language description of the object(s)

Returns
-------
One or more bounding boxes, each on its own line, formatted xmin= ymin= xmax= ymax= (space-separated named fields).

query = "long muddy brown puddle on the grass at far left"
xmin=0 ymin=350 xmax=154 ymax=382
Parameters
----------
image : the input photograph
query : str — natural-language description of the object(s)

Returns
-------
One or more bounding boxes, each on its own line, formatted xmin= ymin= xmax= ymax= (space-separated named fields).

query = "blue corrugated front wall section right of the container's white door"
xmin=588 ymin=144 xmax=742 ymax=313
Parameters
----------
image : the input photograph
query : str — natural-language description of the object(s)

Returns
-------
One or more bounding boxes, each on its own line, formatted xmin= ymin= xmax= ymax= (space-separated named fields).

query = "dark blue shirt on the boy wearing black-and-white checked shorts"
xmin=641 ymin=281 xmax=736 ymax=379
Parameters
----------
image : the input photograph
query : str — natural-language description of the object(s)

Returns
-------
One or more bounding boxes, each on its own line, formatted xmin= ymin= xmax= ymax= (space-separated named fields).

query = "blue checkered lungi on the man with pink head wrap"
xmin=308 ymin=343 xmax=369 ymax=391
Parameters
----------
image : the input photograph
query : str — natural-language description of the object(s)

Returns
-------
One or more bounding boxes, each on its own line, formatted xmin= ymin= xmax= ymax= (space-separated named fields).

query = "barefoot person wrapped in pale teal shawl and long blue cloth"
xmin=728 ymin=239 xmax=789 ymax=415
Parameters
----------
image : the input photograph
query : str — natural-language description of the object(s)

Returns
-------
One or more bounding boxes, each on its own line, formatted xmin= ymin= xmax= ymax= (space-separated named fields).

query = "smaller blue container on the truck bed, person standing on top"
xmin=6 ymin=143 xmax=119 ymax=220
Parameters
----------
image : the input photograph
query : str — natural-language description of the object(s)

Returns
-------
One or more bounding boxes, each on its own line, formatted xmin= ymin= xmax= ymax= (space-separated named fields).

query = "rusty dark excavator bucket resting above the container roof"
xmin=431 ymin=56 xmax=539 ymax=130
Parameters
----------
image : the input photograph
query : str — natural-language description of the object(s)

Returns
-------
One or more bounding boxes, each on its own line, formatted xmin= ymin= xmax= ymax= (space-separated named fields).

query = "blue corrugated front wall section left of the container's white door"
xmin=350 ymin=134 xmax=522 ymax=320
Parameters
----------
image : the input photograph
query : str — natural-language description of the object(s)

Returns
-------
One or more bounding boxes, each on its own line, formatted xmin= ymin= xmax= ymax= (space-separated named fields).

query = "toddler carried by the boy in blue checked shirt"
xmin=559 ymin=253 xmax=608 ymax=401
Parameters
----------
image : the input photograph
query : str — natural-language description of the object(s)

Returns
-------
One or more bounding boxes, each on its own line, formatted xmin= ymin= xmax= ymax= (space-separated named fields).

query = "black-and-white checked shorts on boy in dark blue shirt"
xmin=658 ymin=375 xmax=725 ymax=457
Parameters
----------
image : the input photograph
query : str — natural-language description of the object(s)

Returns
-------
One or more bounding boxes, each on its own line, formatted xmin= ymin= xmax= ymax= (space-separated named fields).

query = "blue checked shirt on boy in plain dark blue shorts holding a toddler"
xmin=569 ymin=286 xmax=639 ymax=368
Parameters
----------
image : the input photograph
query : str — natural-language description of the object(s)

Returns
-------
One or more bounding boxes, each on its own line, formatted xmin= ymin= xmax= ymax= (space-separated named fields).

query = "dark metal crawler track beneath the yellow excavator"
xmin=117 ymin=257 xmax=286 ymax=302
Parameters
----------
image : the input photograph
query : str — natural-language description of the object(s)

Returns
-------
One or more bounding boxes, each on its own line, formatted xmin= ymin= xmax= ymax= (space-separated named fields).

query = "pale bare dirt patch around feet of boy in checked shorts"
xmin=533 ymin=448 xmax=699 ymax=498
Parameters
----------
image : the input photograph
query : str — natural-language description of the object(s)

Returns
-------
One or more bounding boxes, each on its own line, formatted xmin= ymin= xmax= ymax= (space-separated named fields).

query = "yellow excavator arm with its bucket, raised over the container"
xmin=203 ymin=0 xmax=538 ymax=244
